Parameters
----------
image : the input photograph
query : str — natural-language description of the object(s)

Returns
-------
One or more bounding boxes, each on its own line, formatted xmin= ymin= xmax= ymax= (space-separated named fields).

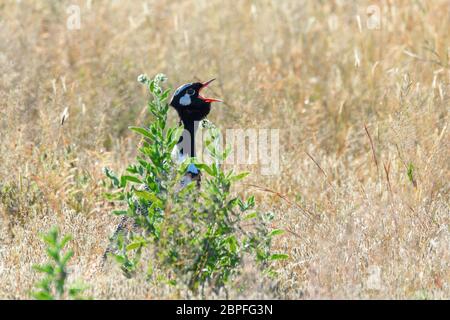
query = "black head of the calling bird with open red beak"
xmin=170 ymin=79 xmax=221 ymax=122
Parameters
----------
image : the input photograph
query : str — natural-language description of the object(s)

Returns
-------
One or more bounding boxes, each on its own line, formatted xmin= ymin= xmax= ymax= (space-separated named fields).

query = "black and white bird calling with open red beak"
xmin=170 ymin=79 xmax=221 ymax=185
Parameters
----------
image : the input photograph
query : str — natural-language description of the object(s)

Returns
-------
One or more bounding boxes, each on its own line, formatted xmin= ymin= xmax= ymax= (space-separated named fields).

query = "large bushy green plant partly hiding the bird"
xmin=105 ymin=75 xmax=287 ymax=291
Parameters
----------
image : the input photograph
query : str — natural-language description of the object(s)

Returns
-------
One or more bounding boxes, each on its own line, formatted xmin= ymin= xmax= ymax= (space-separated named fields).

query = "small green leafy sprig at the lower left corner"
xmin=31 ymin=228 xmax=86 ymax=300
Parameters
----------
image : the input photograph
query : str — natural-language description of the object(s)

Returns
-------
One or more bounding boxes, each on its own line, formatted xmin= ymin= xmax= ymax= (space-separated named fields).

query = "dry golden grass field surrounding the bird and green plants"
xmin=0 ymin=0 xmax=450 ymax=299
